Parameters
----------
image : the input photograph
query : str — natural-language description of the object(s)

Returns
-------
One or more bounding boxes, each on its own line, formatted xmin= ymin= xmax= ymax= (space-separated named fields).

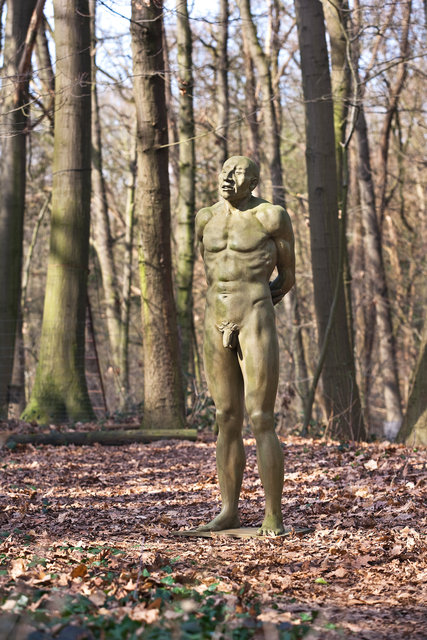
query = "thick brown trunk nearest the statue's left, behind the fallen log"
xmin=131 ymin=0 xmax=184 ymax=428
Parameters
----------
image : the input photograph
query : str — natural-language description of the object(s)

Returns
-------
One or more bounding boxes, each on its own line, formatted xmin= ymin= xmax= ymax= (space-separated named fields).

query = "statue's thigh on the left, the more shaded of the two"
xmin=203 ymin=326 xmax=243 ymax=411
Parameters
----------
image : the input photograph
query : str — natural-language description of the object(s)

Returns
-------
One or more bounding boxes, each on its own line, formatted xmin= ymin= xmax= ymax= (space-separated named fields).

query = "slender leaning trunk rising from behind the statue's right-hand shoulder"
xmin=238 ymin=0 xmax=285 ymax=207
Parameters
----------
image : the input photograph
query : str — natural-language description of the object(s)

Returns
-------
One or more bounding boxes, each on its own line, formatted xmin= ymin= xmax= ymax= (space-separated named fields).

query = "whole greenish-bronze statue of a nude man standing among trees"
xmin=196 ymin=156 xmax=295 ymax=535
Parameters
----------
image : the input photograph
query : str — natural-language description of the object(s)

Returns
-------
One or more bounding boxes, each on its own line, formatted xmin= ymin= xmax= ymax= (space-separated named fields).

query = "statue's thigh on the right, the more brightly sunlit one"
xmin=239 ymin=310 xmax=279 ymax=414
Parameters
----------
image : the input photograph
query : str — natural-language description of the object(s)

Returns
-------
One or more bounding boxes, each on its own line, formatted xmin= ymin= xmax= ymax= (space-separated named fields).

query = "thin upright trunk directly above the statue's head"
xmin=217 ymin=0 xmax=230 ymax=166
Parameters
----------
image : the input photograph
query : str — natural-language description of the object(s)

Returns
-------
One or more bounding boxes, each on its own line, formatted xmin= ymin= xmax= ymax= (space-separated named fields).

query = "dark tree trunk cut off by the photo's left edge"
xmin=0 ymin=0 xmax=36 ymax=417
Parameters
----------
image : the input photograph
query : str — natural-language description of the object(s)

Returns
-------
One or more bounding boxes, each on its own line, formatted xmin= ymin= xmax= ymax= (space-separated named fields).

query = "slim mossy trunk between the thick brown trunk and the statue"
xmin=176 ymin=0 xmax=195 ymax=384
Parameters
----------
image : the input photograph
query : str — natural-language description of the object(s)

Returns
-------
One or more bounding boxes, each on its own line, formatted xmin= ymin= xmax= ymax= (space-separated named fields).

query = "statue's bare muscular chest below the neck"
xmin=203 ymin=214 xmax=267 ymax=252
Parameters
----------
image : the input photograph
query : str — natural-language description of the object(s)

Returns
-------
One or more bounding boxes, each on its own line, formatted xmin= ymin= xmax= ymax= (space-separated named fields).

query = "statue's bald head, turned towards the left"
xmin=219 ymin=156 xmax=259 ymax=203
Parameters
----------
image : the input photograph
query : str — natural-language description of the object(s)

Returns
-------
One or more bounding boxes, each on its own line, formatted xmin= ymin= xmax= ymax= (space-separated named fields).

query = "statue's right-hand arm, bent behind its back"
xmin=270 ymin=207 xmax=295 ymax=304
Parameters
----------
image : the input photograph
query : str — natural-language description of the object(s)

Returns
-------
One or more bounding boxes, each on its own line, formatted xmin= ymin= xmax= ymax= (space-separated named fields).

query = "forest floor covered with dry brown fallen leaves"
xmin=0 ymin=425 xmax=427 ymax=640
